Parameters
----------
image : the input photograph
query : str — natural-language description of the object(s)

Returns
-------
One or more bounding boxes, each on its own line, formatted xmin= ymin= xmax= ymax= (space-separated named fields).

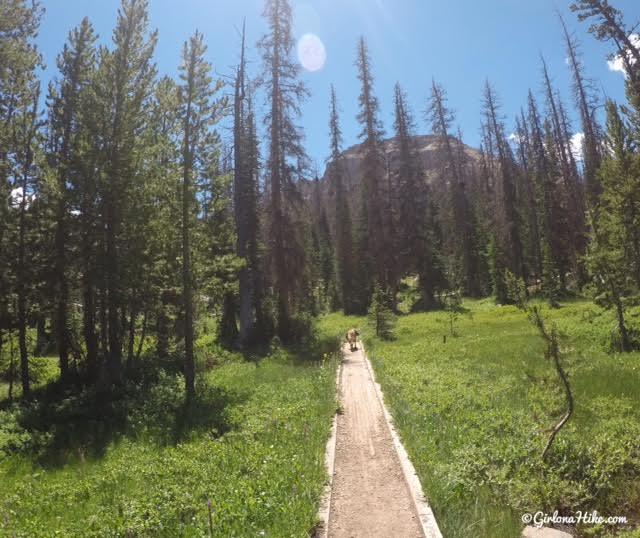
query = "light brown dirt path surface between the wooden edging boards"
xmin=328 ymin=346 xmax=424 ymax=538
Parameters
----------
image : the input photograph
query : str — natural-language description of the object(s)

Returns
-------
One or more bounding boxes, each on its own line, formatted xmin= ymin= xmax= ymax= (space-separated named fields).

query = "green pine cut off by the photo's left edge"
xmin=0 ymin=0 xmax=43 ymax=396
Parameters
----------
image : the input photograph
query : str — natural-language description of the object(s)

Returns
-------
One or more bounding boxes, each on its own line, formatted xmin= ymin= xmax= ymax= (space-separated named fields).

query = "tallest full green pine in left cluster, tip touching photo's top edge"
xmin=95 ymin=0 xmax=157 ymax=383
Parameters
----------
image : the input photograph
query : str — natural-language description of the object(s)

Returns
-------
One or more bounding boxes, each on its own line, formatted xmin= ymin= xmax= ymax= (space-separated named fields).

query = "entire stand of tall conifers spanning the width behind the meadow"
xmin=0 ymin=0 xmax=640 ymax=398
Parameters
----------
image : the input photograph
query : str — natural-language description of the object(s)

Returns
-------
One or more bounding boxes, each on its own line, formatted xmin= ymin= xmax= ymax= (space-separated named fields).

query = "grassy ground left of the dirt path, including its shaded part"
xmin=0 ymin=338 xmax=336 ymax=538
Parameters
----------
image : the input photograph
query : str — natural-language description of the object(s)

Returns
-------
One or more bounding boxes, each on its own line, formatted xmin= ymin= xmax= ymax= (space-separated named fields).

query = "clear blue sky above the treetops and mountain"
xmin=38 ymin=0 xmax=640 ymax=172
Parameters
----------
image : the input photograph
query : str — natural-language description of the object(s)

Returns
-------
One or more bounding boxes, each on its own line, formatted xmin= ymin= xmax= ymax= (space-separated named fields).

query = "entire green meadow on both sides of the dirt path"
xmin=5 ymin=300 xmax=640 ymax=538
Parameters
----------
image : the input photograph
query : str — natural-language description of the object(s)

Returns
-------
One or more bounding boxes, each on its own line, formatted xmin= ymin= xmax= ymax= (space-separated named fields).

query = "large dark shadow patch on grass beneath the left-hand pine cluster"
xmin=0 ymin=370 xmax=247 ymax=467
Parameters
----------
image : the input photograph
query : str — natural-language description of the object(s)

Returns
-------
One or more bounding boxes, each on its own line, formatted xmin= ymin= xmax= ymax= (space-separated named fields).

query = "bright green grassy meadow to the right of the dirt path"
xmin=320 ymin=300 xmax=640 ymax=538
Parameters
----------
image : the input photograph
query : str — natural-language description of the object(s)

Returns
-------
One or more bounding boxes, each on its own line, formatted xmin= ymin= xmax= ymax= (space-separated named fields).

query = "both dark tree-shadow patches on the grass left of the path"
xmin=0 ymin=320 xmax=340 ymax=468
